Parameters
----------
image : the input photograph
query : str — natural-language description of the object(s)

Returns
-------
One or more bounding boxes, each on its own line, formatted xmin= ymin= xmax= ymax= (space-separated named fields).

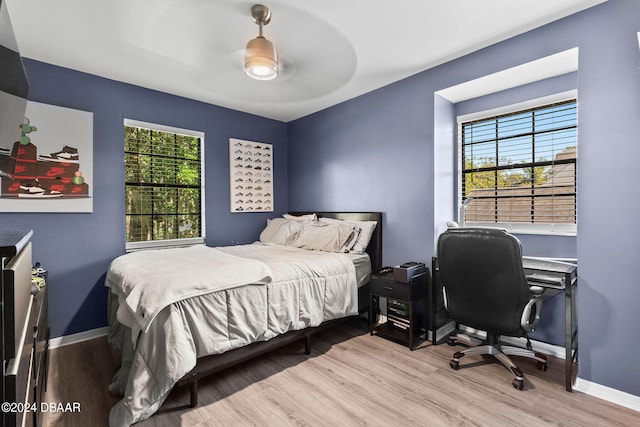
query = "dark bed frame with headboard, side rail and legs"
xmin=175 ymin=212 xmax=382 ymax=407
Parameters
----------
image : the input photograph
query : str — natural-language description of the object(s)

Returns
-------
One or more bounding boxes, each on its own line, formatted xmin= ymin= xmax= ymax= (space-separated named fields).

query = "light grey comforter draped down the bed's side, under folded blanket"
xmin=102 ymin=243 xmax=358 ymax=426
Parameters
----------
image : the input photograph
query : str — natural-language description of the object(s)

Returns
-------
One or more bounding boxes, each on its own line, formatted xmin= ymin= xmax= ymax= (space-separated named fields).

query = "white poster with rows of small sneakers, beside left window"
xmin=229 ymin=138 xmax=273 ymax=213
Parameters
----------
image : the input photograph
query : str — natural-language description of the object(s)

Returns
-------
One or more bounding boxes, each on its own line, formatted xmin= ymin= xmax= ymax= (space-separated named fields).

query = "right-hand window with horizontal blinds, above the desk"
xmin=459 ymin=99 xmax=578 ymax=234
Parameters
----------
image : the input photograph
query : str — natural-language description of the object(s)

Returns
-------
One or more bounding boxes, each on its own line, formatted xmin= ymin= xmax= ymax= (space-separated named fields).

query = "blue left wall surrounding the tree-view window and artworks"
xmin=0 ymin=60 xmax=288 ymax=337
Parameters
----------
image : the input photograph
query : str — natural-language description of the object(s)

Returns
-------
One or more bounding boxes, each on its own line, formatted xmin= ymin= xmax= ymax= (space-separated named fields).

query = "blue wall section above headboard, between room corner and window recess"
xmin=288 ymin=78 xmax=434 ymax=265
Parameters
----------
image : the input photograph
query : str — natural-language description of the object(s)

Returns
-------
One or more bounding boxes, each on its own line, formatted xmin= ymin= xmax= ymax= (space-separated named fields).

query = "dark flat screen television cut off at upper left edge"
xmin=0 ymin=0 xmax=29 ymax=154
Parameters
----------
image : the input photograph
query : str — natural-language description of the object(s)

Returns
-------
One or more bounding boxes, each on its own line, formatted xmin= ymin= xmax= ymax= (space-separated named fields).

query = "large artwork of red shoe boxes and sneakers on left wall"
xmin=0 ymin=101 xmax=93 ymax=212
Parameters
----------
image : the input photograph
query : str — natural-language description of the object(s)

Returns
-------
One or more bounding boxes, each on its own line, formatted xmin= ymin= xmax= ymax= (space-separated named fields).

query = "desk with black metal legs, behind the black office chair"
xmin=431 ymin=257 xmax=578 ymax=391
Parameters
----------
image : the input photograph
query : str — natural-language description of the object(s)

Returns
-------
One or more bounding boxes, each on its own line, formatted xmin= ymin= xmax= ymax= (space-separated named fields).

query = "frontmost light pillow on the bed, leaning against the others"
xmin=290 ymin=221 xmax=357 ymax=252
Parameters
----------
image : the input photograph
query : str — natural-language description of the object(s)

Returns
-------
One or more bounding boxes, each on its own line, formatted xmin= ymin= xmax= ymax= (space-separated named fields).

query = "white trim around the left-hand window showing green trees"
xmin=122 ymin=117 xmax=207 ymax=252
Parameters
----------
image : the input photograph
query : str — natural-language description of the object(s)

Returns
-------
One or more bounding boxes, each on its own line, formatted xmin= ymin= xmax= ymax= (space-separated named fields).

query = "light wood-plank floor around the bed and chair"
xmin=44 ymin=322 xmax=640 ymax=427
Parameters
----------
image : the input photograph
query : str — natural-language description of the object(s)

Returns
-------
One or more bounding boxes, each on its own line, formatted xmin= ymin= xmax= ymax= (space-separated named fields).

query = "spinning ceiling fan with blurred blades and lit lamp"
xmin=182 ymin=0 xmax=357 ymax=106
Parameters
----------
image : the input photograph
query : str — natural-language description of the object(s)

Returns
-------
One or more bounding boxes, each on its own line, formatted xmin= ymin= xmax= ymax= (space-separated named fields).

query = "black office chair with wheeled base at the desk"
xmin=438 ymin=228 xmax=547 ymax=390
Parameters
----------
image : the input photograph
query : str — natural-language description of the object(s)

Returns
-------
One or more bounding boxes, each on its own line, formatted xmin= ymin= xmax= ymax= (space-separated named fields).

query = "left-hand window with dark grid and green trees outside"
xmin=124 ymin=120 xmax=204 ymax=250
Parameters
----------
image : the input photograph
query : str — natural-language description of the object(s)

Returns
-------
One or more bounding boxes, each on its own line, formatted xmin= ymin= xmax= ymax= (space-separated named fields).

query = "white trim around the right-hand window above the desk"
xmin=455 ymin=90 xmax=579 ymax=236
